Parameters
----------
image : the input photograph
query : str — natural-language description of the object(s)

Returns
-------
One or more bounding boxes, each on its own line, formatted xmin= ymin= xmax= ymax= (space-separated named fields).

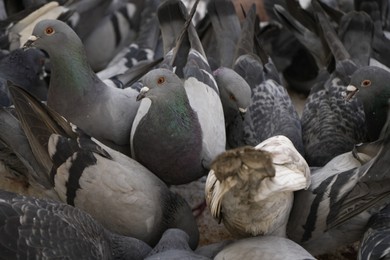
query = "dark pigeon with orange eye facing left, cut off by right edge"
xmin=347 ymin=66 xmax=390 ymax=141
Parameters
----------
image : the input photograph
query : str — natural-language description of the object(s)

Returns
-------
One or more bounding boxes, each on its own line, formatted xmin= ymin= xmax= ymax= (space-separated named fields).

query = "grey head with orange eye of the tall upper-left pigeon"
xmin=23 ymin=19 xmax=83 ymax=56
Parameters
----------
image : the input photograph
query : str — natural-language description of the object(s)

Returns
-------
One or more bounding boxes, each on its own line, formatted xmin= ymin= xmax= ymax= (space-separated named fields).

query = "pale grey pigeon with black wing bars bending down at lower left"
xmin=10 ymin=85 xmax=199 ymax=248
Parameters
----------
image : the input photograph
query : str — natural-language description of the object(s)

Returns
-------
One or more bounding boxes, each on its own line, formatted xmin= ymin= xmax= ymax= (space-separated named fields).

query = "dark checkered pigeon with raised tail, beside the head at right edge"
xmin=301 ymin=1 xmax=372 ymax=167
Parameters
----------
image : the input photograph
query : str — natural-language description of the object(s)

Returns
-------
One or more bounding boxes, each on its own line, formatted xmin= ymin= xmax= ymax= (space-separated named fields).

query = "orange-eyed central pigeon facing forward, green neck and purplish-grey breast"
xmin=131 ymin=68 xmax=204 ymax=185
